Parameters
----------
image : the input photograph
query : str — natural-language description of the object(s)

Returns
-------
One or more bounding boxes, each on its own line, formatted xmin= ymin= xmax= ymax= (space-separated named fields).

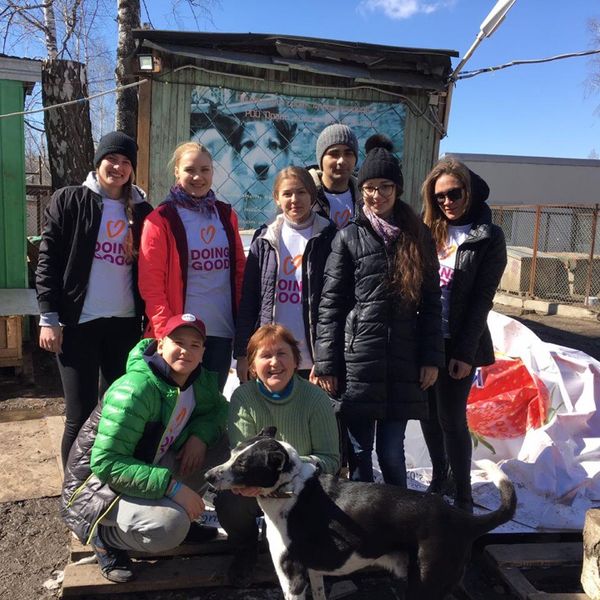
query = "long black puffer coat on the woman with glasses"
xmin=315 ymin=211 xmax=444 ymax=419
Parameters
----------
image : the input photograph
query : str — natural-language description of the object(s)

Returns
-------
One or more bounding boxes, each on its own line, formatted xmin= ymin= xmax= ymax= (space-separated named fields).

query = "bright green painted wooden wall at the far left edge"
xmin=0 ymin=79 xmax=28 ymax=289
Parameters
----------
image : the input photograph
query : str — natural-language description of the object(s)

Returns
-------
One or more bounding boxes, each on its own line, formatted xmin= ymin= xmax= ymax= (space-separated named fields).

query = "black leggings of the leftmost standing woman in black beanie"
xmin=58 ymin=317 xmax=141 ymax=466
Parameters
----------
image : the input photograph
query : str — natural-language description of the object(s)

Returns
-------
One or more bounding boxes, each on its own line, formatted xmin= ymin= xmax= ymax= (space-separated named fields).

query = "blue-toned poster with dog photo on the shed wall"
xmin=190 ymin=86 xmax=406 ymax=229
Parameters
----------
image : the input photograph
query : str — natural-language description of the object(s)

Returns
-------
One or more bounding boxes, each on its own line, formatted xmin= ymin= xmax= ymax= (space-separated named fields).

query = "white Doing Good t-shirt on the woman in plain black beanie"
xmin=79 ymin=197 xmax=135 ymax=323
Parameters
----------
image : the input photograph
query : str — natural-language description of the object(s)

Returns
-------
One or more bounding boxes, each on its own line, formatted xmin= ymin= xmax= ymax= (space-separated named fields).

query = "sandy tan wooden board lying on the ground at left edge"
xmin=0 ymin=419 xmax=62 ymax=502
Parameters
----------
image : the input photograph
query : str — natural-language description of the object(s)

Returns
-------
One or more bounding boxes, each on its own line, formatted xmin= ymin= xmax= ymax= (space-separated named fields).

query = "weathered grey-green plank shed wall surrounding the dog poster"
xmin=142 ymin=67 xmax=435 ymax=211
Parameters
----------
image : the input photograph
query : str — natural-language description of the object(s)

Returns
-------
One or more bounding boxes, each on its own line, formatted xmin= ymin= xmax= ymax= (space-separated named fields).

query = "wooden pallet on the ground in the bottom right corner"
xmin=484 ymin=542 xmax=589 ymax=600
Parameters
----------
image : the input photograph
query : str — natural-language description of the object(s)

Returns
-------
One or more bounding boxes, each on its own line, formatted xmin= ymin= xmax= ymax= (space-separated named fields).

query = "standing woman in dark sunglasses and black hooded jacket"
xmin=421 ymin=157 xmax=506 ymax=512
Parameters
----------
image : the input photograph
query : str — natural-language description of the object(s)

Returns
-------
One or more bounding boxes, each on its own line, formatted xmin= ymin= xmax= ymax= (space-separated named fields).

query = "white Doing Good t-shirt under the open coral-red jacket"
xmin=177 ymin=206 xmax=234 ymax=338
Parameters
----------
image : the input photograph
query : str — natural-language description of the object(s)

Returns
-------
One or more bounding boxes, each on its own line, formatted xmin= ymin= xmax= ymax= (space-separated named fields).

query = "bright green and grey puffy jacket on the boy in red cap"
xmin=61 ymin=339 xmax=228 ymax=541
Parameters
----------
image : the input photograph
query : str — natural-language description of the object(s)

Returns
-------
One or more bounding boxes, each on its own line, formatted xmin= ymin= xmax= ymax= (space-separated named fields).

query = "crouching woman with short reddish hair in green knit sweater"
xmin=215 ymin=324 xmax=340 ymax=587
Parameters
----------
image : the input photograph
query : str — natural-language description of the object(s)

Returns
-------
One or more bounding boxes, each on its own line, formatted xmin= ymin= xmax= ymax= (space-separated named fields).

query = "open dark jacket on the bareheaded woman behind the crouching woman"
xmin=233 ymin=214 xmax=337 ymax=358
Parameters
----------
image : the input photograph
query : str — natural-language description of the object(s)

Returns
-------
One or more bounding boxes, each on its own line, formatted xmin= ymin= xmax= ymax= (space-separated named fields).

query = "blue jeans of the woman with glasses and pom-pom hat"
xmin=345 ymin=419 xmax=407 ymax=488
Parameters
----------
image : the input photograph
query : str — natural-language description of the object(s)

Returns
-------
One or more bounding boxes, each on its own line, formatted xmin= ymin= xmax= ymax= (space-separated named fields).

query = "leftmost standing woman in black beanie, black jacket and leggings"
xmin=36 ymin=131 xmax=152 ymax=464
